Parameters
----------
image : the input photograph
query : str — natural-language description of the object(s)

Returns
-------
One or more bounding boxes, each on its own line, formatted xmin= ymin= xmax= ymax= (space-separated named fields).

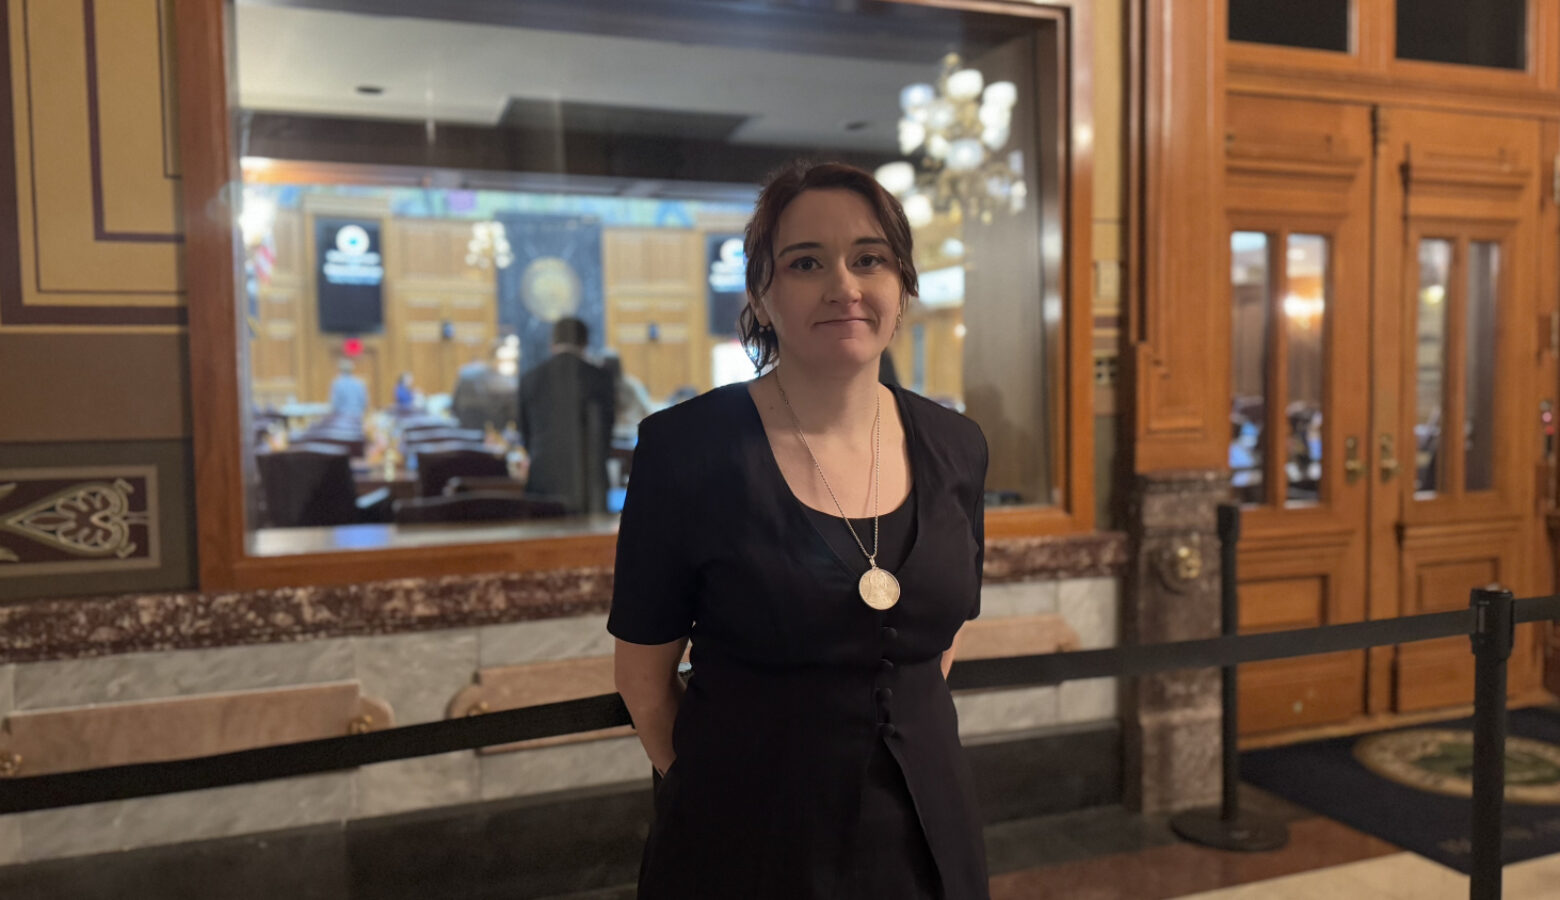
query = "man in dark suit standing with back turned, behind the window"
xmin=519 ymin=318 xmax=616 ymax=513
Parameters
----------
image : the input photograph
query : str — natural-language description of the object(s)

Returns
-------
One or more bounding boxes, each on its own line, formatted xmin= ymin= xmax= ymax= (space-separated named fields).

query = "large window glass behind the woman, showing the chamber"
xmin=204 ymin=0 xmax=1070 ymax=574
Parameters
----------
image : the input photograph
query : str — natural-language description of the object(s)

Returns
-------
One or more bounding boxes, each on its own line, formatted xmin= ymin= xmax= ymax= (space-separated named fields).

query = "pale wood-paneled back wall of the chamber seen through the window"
xmin=250 ymin=206 xmax=742 ymax=406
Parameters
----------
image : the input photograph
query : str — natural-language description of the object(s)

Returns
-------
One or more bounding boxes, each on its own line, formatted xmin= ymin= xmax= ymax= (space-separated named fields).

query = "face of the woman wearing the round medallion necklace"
xmin=753 ymin=189 xmax=903 ymax=371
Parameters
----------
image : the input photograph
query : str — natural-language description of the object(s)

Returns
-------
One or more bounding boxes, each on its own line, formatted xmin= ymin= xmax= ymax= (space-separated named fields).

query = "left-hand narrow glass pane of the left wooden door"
xmin=1229 ymin=231 xmax=1273 ymax=505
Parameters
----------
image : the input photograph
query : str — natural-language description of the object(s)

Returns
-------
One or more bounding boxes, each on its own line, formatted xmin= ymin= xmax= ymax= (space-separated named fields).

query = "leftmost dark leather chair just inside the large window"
xmin=254 ymin=443 xmax=390 ymax=529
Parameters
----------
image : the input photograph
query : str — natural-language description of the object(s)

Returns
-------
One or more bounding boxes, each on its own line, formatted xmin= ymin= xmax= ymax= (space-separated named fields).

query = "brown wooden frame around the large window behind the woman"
xmin=175 ymin=0 xmax=1095 ymax=591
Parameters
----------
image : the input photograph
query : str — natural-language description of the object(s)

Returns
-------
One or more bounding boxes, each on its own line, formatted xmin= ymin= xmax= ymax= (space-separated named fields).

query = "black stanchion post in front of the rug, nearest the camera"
xmin=1468 ymin=588 xmax=1516 ymax=900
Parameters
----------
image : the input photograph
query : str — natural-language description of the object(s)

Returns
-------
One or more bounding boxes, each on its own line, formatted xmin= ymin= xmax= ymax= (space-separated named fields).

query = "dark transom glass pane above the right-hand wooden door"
xmin=1398 ymin=0 xmax=1527 ymax=69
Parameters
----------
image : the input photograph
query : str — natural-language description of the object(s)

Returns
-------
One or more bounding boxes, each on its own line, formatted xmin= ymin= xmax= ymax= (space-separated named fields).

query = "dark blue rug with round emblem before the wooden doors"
xmin=1240 ymin=708 xmax=1560 ymax=872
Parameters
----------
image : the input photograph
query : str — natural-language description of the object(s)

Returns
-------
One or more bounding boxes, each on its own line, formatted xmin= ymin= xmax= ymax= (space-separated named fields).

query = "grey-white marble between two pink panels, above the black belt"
xmin=353 ymin=629 xmax=477 ymax=725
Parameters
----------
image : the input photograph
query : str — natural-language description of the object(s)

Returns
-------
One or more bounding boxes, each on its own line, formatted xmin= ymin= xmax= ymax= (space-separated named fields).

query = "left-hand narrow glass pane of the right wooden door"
xmin=1413 ymin=239 xmax=1452 ymax=499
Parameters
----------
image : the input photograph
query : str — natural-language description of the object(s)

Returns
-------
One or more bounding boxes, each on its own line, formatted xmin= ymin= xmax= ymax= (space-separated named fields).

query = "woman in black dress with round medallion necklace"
xmin=607 ymin=164 xmax=987 ymax=900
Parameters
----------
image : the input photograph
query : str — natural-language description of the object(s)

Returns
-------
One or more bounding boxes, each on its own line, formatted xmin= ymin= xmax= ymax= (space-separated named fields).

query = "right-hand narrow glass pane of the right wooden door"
xmin=1463 ymin=240 xmax=1501 ymax=491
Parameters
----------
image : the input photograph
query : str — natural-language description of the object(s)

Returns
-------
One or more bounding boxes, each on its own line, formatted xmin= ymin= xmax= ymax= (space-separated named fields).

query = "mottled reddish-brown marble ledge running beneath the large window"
xmin=0 ymin=532 xmax=1128 ymax=664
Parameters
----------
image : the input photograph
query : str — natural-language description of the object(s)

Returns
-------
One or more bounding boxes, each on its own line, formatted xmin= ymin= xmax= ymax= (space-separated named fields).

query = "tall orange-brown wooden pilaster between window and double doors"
xmin=1128 ymin=0 xmax=1229 ymax=471
